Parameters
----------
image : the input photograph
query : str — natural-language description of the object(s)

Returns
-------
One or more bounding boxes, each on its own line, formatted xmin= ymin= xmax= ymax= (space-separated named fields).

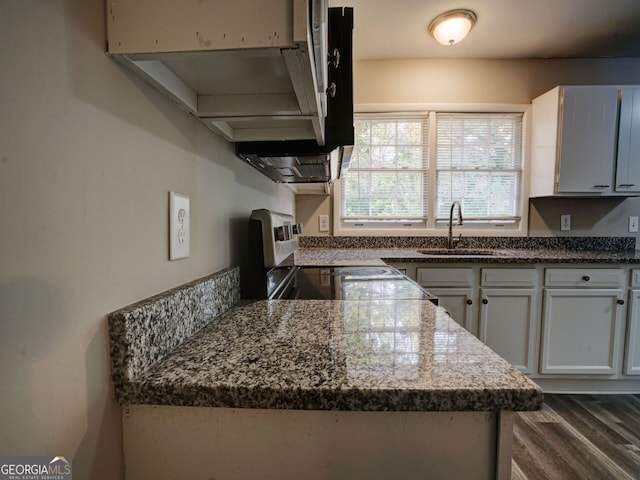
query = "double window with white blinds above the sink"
xmin=340 ymin=112 xmax=523 ymax=234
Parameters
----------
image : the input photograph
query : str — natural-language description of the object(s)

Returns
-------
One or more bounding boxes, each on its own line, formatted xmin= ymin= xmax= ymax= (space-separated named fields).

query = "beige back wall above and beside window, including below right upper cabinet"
xmin=297 ymin=59 xmax=640 ymax=235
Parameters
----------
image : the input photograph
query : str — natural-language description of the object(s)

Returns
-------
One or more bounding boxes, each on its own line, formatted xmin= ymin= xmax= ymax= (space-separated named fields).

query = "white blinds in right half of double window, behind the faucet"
xmin=436 ymin=113 xmax=522 ymax=223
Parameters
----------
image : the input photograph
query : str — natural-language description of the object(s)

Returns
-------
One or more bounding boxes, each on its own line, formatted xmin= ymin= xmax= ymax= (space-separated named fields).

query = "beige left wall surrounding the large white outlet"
xmin=0 ymin=0 xmax=294 ymax=480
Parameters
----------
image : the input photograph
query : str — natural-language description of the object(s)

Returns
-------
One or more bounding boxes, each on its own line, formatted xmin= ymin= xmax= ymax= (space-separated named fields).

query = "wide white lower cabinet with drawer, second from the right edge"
xmin=540 ymin=269 xmax=626 ymax=375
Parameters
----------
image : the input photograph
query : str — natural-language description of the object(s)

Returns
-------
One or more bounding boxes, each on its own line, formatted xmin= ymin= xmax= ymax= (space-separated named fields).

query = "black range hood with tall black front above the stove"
xmin=236 ymin=7 xmax=354 ymax=188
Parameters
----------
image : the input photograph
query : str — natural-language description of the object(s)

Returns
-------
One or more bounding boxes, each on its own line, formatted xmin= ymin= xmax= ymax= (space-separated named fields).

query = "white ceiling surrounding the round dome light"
xmin=330 ymin=0 xmax=640 ymax=60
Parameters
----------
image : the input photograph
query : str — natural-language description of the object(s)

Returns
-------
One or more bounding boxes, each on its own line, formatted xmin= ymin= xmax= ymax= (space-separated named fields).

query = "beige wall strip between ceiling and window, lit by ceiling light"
xmin=354 ymin=59 xmax=640 ymax=104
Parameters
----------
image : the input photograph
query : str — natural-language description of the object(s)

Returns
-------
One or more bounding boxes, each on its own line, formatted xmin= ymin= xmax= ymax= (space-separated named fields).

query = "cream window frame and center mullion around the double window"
xmin=332 ymin=104 xmax=531 ymax=237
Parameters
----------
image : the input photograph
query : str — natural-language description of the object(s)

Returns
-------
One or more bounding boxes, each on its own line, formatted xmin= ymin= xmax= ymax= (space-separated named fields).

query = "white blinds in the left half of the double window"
xmin=341 ymin=115 xmax=429 ymax=222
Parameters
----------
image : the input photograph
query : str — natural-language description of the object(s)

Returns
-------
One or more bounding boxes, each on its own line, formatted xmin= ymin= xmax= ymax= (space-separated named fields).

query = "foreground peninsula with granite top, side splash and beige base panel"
xmin=109 ymin=268 xmax=543 ymax=480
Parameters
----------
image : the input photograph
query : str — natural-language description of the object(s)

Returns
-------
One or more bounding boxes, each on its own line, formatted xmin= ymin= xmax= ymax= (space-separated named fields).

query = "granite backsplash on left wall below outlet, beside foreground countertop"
xmin=108 ymin=267 xmax=240 ymax=396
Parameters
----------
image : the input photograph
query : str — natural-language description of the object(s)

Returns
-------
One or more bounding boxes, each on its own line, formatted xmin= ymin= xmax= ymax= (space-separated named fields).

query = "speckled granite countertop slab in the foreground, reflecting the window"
xmin=119 ymin=300 xmax=542 ymax=411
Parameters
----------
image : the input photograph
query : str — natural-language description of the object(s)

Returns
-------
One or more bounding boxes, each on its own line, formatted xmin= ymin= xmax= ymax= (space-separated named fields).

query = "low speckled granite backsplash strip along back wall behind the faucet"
xmin=298 ymin=235 xmax=636 ymax=252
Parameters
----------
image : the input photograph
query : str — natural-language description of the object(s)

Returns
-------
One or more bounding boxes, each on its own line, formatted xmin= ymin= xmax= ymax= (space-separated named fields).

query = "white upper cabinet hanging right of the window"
xmin=530 ymin=86 xmax=640 ymax=197
